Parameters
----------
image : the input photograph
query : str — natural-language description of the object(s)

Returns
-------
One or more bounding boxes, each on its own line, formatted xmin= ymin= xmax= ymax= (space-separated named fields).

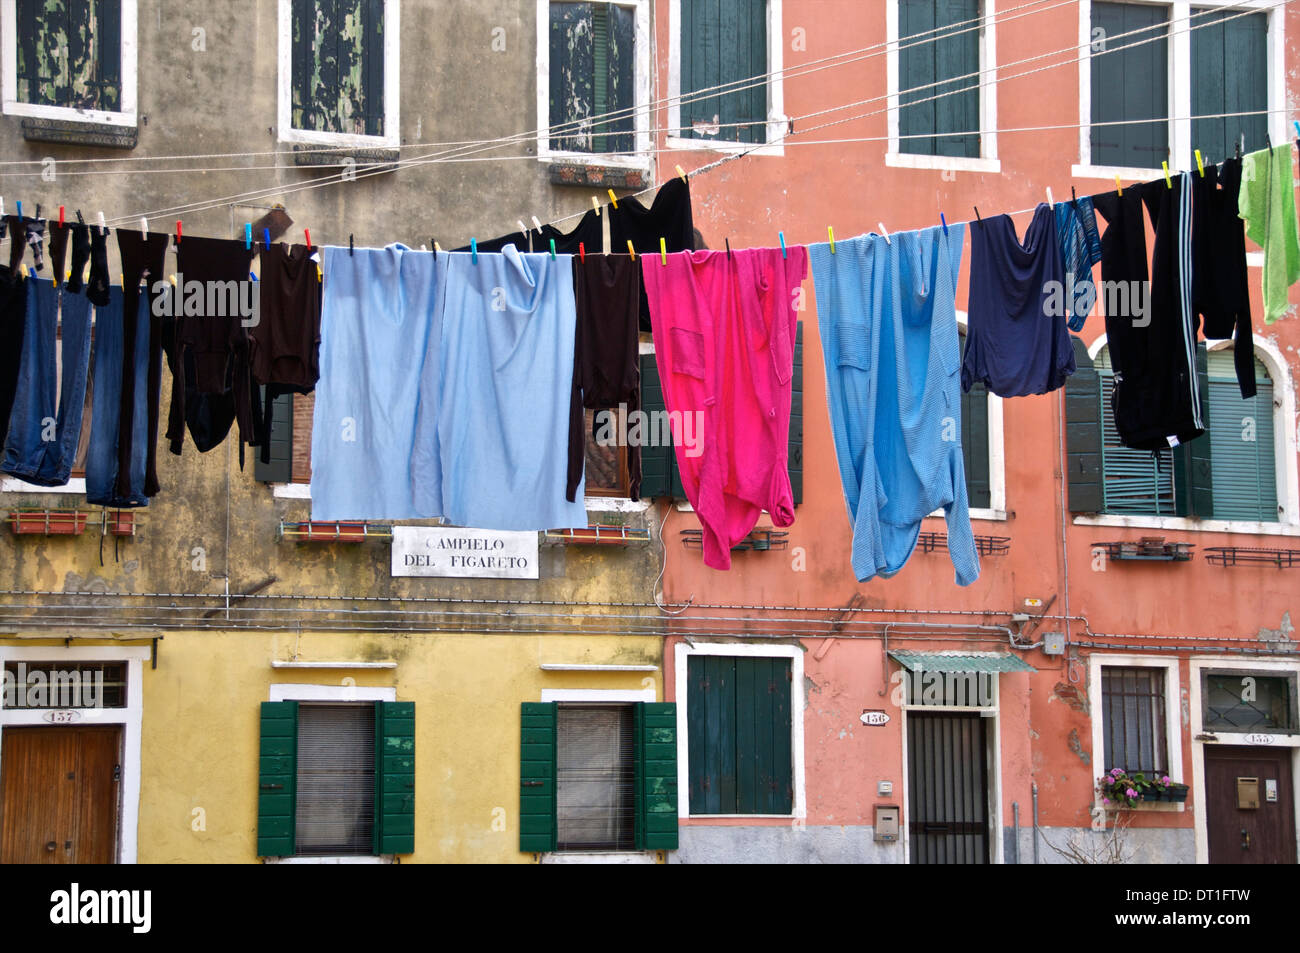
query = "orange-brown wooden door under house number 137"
xmin=0 ymin=725 xmax=122 ymax=863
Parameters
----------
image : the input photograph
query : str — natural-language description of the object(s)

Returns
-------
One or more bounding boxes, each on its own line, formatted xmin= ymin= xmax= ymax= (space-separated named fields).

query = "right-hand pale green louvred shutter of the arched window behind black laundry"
xmin=1195 ymin=350 xmax=1278 ymax=523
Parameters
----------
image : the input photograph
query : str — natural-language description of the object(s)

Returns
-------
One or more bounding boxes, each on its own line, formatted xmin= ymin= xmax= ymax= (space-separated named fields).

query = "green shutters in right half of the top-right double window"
xmin=1191 ymin=9 xmax=1269 ymax=164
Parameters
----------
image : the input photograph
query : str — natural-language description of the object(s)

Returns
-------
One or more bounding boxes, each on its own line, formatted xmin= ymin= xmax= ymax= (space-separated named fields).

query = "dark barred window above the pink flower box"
xmin=1099 ymin=666 xmax=1170 ymax=774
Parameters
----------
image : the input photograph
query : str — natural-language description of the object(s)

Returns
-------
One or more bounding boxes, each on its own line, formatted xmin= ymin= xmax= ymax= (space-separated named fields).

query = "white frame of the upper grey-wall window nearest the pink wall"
xmin=537 ymin=0 xmax=651 ymax=174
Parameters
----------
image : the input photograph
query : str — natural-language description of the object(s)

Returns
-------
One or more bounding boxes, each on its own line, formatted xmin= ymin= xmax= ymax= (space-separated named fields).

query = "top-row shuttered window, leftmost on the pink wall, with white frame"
xmin=670 ymin=0 xmax=785 ymax=144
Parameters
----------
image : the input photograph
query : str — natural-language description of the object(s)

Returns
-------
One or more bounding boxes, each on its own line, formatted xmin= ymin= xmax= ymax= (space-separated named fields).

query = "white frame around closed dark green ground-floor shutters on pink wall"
xmin=673 ymin=642 xmax=807 ymax=822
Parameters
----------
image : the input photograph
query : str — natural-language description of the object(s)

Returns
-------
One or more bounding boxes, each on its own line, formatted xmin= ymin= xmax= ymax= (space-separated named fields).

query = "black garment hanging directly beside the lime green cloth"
xmin=1192 ymin=159 xmax=1256 ymax=398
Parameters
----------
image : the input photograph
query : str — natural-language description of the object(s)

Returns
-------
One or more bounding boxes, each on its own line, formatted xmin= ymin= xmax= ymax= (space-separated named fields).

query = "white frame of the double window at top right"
xmin=1070 ymin=0 xmax=1290 ymax=181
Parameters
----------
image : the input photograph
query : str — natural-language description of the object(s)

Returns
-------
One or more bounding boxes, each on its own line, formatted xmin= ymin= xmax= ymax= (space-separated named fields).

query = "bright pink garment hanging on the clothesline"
xmin=639 ymin=247 xmax=807 ymax=569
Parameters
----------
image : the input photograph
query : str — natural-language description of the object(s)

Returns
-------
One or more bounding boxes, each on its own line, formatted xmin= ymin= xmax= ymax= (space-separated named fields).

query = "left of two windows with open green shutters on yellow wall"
xmin=257 ymin=698 xmax=415 ymax=857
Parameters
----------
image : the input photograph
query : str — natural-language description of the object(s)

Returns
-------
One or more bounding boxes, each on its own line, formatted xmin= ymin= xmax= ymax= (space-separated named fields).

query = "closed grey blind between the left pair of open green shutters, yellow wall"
xmin=294 ymin=702 xmax=376 ymax=857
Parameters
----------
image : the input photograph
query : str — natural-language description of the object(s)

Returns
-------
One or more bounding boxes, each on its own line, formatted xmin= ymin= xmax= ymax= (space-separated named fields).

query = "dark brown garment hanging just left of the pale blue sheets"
xmin=248 ymin=243 xmax=321 ymax=463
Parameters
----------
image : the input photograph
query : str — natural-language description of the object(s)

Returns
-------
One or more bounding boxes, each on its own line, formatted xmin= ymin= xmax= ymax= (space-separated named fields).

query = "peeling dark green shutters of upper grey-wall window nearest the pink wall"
xmin=549 ymin=0 xmax=636 ymax=153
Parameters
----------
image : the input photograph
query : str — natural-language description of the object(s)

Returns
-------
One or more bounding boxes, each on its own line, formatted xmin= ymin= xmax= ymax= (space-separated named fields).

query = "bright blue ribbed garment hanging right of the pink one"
xmin=809 ymin=228 xmax=977 ymax=585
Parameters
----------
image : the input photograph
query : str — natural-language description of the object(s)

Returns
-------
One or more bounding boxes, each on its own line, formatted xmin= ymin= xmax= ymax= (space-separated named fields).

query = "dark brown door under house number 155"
xmin=1205 ymin=745 xmax=1296 ymax=863
